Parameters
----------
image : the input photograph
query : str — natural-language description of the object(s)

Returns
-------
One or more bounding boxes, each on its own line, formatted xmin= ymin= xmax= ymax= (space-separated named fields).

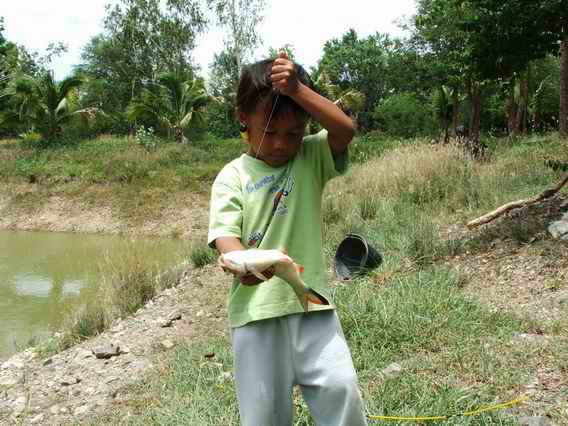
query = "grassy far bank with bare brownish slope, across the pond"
xmin=0 ymin=137 xmax=402 ymax=226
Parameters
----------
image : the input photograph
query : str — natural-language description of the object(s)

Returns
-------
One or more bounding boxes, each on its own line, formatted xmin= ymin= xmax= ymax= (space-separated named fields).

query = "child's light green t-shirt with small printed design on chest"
xmin=208 ymin=130 xmax=348 ymax=327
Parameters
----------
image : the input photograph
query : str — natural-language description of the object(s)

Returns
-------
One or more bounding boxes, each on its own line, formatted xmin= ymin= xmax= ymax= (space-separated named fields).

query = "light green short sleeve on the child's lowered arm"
xmin=207 ymin=169 xmax=243 ymax=248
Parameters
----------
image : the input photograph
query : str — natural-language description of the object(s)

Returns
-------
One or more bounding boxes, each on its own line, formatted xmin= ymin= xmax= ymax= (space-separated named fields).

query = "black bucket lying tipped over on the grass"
xmin=333 ymin=233 xmax=383 ymax=281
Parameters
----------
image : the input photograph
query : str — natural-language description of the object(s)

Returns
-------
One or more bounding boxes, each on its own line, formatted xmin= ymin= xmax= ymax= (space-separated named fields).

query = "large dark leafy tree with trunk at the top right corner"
xmin=415 ymin=0 xmax=568 ymax=140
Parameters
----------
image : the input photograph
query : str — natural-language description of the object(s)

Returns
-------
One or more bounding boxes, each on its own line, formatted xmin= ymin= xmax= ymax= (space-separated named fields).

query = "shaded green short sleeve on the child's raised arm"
xmin=304 ymin=129 xmax=349 ymax=184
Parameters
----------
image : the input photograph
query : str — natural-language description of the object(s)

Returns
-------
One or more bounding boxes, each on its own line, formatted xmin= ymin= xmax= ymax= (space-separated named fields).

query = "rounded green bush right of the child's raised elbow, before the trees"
xmin=373 ymin=93 xmax=438 ymax=138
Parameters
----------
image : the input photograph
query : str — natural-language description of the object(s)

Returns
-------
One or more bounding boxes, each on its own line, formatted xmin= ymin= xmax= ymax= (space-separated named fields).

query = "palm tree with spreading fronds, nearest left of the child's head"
xmin=127 ymin=73 xmax=213 ymax=143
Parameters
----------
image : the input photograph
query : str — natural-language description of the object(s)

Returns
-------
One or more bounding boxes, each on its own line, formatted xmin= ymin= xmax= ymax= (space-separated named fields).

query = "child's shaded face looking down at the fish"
xmin=241 ymin=102 xmax=308 ymax=167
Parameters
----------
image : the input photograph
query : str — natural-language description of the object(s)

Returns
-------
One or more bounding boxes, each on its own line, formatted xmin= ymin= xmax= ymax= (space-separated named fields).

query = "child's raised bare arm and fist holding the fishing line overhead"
xmin=271 ymin=53 xmax=355 ymax=157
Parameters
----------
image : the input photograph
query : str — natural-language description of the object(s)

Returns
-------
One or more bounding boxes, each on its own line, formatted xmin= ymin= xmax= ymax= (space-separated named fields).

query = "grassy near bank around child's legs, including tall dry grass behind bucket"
xmin=84 ymin=135 xmax=568 ymax=425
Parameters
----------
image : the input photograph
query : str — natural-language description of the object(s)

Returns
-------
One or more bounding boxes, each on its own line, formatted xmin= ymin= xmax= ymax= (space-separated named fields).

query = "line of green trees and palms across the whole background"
xmin=0 ymin=0 xmax=568 ymax=145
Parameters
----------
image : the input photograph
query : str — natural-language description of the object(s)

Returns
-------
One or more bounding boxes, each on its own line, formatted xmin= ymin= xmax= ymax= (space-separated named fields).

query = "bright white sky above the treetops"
xmin=0 ymin=0 xmax=416 ymax=79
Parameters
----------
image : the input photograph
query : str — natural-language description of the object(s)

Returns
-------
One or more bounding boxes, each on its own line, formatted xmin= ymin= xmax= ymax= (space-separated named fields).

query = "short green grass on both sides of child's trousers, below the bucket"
xmin=87 ymin=270 xmax=534 ymax=425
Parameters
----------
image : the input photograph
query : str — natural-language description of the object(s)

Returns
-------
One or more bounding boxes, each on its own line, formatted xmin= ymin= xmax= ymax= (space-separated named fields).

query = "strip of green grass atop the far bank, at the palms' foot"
xmin=0 ymin=137 xmax=244 ymax=190
